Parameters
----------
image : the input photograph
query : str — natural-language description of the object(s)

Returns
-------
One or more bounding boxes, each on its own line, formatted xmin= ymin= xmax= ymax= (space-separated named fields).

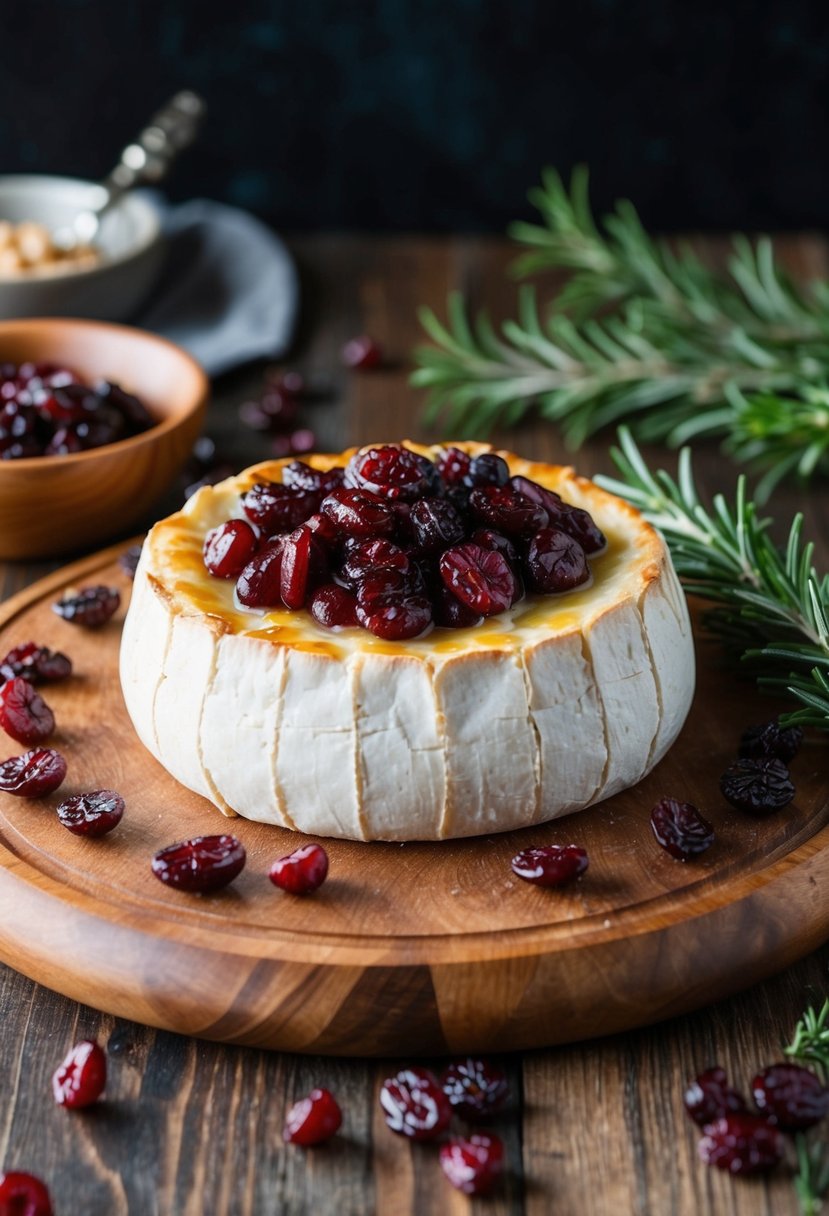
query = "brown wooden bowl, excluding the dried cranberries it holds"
xmin=0 ymin=317 xmax=208 ymax=558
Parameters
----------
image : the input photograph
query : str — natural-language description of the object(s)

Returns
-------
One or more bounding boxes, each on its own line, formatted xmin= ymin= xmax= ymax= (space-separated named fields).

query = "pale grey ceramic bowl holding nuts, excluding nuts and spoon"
xmin=0 ymin=175 xmax=164 ymax=321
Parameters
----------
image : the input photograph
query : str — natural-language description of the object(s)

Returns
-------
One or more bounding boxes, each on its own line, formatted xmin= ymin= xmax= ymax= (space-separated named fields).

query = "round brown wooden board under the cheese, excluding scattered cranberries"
xmin=0 ymin=546 xmax=829 ymax=1055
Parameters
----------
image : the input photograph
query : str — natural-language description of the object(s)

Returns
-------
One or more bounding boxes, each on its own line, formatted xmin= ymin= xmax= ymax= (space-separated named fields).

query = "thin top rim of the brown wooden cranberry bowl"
xmin=0 ymin=316 xmax=210 ymax=478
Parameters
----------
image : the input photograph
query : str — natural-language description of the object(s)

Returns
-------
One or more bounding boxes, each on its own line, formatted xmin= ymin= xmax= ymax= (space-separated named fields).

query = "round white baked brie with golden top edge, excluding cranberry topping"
xmin=120 ymin=444 xmax=694 ymax=840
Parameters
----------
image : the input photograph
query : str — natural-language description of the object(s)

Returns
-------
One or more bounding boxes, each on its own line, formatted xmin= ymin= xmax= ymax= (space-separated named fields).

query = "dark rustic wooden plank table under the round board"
xmin=0 ymin=236 xmax=829 ymax=1216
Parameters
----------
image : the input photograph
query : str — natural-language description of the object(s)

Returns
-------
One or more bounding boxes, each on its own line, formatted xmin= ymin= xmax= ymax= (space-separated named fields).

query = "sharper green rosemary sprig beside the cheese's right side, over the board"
xmin=597 ymin=427 xmax=829 ymax=731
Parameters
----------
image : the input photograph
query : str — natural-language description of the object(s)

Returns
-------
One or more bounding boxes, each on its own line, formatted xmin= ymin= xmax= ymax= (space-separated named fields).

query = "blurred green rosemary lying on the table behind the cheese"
xmin=412 ymin=169 xmax=829 ymax=495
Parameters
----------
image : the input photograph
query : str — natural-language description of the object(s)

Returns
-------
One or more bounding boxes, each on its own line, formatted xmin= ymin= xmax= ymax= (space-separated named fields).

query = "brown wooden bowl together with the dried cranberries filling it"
xmin=0 ymin=319 xmax=208 ymax=559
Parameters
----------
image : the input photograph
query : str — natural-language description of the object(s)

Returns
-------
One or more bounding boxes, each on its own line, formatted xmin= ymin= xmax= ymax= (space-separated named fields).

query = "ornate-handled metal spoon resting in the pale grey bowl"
xmin=52 ymin=89 xmax=207 ymax=249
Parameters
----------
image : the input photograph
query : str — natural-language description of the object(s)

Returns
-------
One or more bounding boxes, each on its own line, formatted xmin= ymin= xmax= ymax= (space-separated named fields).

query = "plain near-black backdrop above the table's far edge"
xmin=6 ymin=0 xmax=829 ymax=230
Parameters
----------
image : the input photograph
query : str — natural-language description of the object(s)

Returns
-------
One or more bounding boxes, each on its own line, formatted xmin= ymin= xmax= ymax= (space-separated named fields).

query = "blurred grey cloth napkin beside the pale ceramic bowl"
xmin=136 ymin=197 xmax=299 ymax=376
